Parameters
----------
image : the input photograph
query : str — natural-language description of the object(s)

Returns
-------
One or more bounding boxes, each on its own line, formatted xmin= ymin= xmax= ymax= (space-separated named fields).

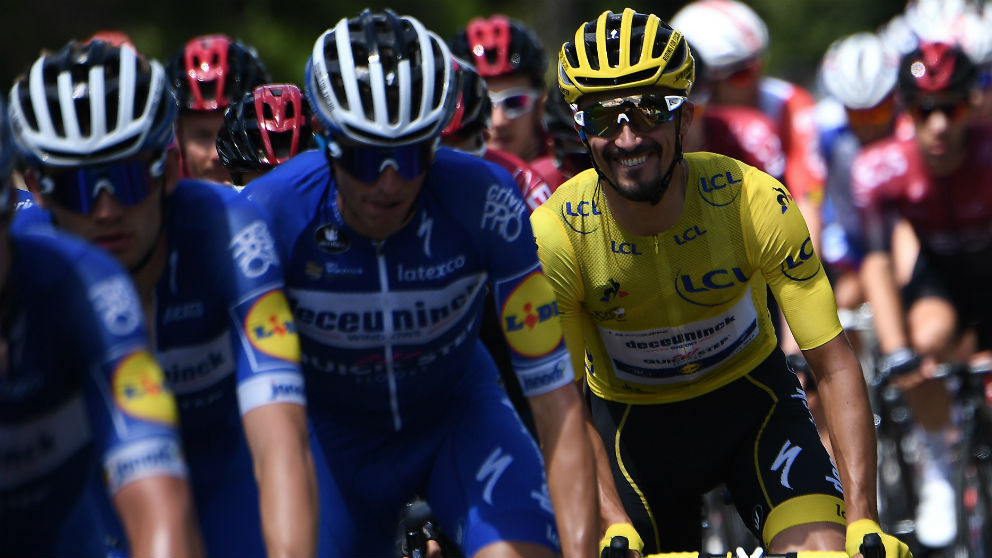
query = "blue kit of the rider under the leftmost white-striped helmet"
xmin=17 ymin=180 xmax=305 ymax=556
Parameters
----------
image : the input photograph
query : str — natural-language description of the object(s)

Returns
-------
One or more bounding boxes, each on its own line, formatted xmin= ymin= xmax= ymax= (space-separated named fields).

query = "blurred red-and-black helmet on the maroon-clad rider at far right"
xmin=899 ymin=43 xmax=975 ymax=97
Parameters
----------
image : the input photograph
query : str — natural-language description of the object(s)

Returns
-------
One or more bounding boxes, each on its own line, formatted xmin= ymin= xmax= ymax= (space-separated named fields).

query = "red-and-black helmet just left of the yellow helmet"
xmin=451 ymin=15 xmax=548 ymax=87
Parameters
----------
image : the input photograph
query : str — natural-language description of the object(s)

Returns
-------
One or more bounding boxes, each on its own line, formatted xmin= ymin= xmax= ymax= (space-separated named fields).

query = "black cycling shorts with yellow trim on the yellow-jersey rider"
xmin=590 ymin=349 xmax=845 ymax=554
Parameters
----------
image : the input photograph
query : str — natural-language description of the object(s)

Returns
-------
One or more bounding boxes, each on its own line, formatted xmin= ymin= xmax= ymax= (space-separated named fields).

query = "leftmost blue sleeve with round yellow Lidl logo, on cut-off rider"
xmin=15 ymin=230 xmax=186 ymax=492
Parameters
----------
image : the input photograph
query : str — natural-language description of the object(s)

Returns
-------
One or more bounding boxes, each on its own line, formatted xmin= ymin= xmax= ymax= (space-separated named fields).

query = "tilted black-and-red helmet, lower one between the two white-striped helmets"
xmin=217 ymin=83 xmax=315 ymax=189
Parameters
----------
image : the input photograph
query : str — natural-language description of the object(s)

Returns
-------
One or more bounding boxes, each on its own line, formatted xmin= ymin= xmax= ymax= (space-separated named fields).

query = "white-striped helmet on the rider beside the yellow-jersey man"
xmin=304 ymin=10 xmax=458 ymax=146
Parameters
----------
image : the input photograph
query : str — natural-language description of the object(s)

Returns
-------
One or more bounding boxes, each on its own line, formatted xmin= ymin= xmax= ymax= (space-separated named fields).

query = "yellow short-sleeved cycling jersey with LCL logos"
xmin=531 ymin=152 xmax=841 ymax=404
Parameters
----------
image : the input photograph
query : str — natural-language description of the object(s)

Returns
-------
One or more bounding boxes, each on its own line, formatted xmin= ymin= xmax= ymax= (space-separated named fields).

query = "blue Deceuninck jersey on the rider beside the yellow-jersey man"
xmin=244 ymin=148 xmax=574 ymax=430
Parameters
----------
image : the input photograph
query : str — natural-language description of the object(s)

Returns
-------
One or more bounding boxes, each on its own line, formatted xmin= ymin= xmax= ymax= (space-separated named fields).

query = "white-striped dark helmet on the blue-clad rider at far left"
xmin=9 ymin=41 xmax=177 ymax=166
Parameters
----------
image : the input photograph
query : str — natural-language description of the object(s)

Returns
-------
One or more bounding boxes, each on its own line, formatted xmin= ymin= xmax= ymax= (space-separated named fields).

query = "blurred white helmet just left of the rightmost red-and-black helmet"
xmin=820 ymin=32 xmax=899 ymax=109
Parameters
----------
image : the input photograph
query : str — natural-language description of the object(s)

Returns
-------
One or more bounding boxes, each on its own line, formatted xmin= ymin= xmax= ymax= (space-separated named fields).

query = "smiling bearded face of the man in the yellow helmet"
xmin=579 ymin=88 xmax=693 ymax=207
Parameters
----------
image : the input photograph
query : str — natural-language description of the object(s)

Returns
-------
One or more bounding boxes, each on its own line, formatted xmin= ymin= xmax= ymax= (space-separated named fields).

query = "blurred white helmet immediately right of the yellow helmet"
xmin=670 ymin=0 xmax=768 ymax=76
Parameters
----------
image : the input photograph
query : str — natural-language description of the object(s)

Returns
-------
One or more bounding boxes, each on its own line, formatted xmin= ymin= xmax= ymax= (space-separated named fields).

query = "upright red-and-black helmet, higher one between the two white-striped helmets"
xmin=168 ymin=35 xmax=269 ymax=112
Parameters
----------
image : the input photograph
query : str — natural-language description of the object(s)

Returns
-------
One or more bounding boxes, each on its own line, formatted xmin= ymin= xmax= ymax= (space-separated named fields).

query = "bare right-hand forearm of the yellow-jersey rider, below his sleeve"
xmin=804 ymin=335 xmax=878 ymax=523
